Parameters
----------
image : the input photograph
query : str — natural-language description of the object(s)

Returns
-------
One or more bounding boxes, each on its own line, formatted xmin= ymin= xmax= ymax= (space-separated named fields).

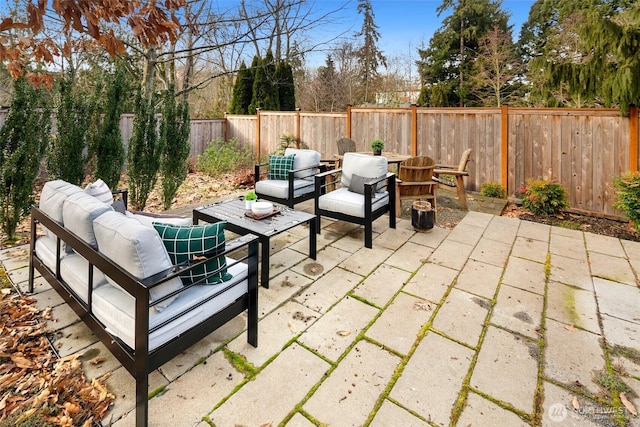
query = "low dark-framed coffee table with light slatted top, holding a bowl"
xmin=193 ymin=199 xmax=317 ymax=288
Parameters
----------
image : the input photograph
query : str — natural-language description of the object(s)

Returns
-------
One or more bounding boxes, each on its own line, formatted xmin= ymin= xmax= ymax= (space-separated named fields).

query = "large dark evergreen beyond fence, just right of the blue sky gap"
xmin=418 ymin=0 xmax=511 ymax=107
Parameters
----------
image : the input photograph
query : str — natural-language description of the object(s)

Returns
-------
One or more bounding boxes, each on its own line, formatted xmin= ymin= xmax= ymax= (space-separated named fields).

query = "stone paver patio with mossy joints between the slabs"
xmin=0 ymin=198 xmax=640 ymax=427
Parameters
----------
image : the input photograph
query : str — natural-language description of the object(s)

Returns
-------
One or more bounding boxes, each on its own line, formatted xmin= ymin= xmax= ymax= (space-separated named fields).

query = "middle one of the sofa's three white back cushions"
xmin=62 ymin=192 xmax=113 ymax=248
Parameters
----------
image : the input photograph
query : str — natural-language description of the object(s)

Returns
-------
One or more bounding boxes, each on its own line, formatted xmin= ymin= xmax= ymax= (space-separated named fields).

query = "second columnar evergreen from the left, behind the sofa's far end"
xmin=47 ymin=68 xmax=91 ymax=185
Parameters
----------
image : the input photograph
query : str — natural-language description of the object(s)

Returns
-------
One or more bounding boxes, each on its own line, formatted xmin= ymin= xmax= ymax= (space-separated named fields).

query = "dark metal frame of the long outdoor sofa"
xmin=29 ymin=206 xmax=258 ymax=427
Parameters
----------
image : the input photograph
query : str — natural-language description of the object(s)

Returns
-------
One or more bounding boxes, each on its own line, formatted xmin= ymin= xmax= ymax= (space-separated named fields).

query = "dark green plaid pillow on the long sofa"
xmin=153 ymin=221 xmax=233 ymax=285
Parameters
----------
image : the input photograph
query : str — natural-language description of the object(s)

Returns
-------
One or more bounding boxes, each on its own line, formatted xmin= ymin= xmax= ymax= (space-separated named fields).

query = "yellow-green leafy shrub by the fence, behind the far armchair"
xmin=196 ymin=138 xmax=255 ymax=176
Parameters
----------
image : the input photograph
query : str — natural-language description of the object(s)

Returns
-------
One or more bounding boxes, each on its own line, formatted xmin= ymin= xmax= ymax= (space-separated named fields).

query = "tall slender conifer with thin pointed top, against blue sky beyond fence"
xmin=356 ymin=0 xmax=387 ymax=103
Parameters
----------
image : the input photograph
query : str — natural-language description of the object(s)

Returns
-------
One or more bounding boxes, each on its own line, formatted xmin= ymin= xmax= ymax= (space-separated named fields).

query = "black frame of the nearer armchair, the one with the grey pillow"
xmin=314 ymin=168 xmax=396 ymax=249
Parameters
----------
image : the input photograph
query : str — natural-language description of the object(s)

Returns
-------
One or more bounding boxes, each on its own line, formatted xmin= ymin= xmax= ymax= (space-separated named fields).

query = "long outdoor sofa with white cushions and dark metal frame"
xmin=29 ymin=180 xmax=258 ymax=427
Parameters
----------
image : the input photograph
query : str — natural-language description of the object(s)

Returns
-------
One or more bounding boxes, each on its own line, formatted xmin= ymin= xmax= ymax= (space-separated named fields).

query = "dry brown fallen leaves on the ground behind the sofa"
xmin=0 ymin=288 xmax=114 ymax=427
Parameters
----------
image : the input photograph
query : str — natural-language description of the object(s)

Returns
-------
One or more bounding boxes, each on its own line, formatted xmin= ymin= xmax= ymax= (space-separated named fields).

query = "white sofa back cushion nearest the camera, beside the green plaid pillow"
xmin=93 ymin=211 xmax=182 ymax=311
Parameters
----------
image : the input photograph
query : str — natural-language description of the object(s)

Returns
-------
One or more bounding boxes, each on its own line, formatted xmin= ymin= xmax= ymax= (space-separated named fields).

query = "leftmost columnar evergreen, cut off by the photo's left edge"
xmin=0 ymin=77 xmax=51 ymax=238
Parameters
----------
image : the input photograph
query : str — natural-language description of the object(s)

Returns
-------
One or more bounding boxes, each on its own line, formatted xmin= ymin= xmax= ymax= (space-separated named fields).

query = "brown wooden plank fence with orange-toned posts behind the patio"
xmin=0 ymin=106 xmax=640 ymax=216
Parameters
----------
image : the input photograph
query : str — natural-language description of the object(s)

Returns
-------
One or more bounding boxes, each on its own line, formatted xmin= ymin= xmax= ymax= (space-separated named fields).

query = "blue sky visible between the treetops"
xmin=304 ymin=0 xmax=534 ymax=68
